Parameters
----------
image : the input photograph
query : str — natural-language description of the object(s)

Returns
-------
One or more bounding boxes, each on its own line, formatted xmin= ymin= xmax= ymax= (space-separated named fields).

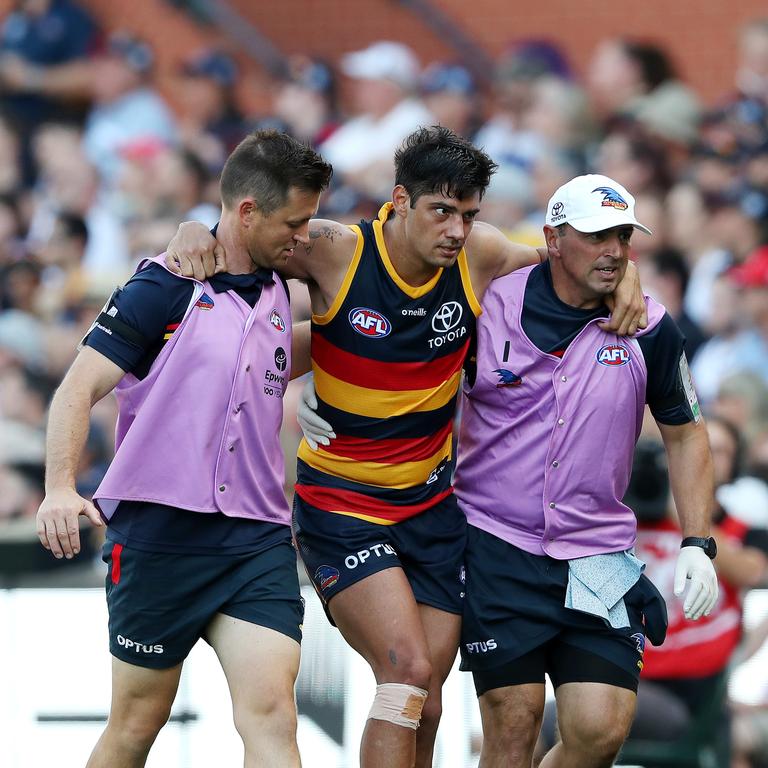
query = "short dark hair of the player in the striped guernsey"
xmin=395 ymin=125 xmax=498 ymax=208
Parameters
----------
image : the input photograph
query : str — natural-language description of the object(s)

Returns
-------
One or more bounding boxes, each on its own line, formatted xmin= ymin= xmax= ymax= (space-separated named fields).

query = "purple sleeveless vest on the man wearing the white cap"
xmin=455 ymin=268 xmax=664 ymax=560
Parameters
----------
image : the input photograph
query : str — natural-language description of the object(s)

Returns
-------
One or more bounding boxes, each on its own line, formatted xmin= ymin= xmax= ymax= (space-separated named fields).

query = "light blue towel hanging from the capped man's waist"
xmin=565 ymin=551 xmax=645 ymax=629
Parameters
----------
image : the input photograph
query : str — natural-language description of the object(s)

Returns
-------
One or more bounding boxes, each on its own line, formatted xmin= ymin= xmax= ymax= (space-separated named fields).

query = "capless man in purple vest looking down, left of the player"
xmin=37 ymin=131 xmax=331 ymax=768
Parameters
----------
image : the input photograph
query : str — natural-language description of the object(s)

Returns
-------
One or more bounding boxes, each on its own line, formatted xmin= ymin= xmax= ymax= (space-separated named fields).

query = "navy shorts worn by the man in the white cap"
xmin=461 ymin=525 xmax=645 ymax=694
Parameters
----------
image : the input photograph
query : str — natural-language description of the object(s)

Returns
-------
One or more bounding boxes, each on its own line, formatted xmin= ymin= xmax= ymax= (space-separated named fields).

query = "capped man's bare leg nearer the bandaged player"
xmin=480 ymin=683 xmax=545 ymax=768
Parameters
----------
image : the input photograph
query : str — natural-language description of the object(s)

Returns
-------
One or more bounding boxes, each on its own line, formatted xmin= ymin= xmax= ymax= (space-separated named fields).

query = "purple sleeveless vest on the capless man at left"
xmin=94 ymin=256 xmax=291 ymax=525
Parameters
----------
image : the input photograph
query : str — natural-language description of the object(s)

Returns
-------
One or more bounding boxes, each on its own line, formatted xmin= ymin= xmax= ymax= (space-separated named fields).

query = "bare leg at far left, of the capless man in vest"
xmin=86 ymin=657 xmax=181 ymax=768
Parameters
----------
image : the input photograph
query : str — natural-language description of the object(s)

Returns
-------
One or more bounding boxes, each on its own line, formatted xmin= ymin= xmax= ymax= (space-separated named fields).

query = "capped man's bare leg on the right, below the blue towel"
xmin=541 ymin=683 xmax=637 ymax=768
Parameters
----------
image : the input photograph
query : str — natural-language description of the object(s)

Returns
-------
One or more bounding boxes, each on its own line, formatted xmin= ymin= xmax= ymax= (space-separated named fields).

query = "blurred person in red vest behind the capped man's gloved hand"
xmin=627 ymin=428 xmax=768 ymax=765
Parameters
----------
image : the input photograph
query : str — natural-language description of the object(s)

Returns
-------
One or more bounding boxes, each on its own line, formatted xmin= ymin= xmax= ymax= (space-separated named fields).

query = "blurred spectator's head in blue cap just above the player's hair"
xmin=420 ymin=62 xmax=480 ymax=138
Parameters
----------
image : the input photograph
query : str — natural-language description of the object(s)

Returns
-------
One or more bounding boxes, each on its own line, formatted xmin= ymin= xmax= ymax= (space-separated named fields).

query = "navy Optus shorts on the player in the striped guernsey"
xmin=293 ymin=495 xmax=467 ymax=614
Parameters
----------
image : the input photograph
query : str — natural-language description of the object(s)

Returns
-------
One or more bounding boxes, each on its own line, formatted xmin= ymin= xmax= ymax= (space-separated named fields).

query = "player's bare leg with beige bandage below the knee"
xmin=328 ymin=567 xmax=432 ymax=768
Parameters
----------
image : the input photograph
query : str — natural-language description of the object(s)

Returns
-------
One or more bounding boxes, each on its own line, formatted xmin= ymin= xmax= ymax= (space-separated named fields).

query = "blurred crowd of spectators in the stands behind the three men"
xmin=0 ymin=2 xmax=768 ymax=768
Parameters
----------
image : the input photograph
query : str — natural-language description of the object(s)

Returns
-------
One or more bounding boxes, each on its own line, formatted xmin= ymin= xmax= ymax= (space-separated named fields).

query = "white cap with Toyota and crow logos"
xmin=546 ymin=173 xmax=653 ymax=235
